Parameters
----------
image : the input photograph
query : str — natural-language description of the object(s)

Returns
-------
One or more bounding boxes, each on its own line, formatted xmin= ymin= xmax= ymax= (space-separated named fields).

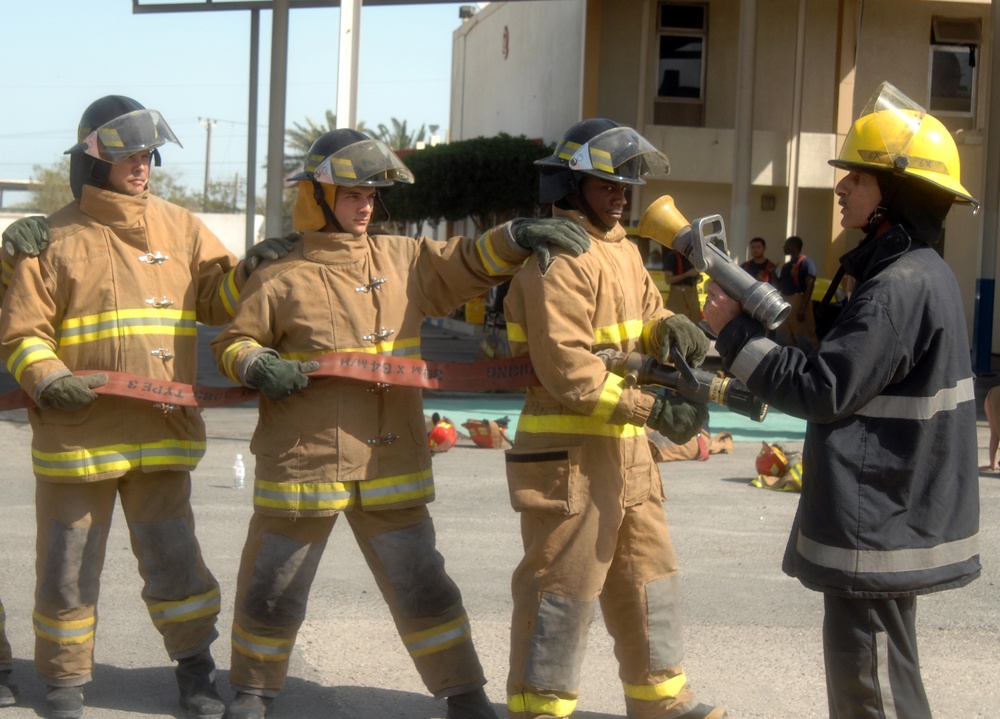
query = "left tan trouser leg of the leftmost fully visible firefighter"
xmin=32 ymin=480 xmax=118 ymax=686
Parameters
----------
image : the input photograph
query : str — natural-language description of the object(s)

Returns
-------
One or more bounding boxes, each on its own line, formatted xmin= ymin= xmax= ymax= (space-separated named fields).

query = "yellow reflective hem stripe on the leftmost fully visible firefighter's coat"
xmin=31 ymin=439 xmax=205 ymax=477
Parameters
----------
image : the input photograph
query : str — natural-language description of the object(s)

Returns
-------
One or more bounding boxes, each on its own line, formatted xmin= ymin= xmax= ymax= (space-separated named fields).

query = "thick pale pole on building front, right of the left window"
xmin=729 ymin=0 xmax=757 ymax=257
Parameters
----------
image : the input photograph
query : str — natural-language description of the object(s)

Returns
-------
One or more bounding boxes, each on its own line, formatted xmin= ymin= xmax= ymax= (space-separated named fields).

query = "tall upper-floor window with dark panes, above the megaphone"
xmin=653 ymin=2 xmax=708 ymax=126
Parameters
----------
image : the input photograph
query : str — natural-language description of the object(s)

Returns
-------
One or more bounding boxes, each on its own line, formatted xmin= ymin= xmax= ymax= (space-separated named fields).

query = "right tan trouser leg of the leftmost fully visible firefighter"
xmin=118 ymin=471 xmax=221 ymax=659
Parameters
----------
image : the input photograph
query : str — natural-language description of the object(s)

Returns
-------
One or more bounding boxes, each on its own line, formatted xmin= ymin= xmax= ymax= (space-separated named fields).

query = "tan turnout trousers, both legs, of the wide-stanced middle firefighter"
xmin=229 ymin=505 xmax=486 ymax=697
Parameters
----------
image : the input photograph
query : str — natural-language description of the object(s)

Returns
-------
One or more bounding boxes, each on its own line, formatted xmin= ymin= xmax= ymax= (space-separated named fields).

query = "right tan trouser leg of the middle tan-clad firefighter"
xmin=347 ymin=505 xmax=486 ymax=697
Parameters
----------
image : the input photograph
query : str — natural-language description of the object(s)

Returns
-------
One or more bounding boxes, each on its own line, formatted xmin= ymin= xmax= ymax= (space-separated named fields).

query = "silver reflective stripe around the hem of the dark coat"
xmin=795 ymin=532 xmax=979 ymax=574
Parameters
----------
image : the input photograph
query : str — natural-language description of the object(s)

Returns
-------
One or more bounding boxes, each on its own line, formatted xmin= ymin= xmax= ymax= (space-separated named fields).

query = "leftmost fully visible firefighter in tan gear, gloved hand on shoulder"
xmin=0 ymin=95 xmax=292 ymax=719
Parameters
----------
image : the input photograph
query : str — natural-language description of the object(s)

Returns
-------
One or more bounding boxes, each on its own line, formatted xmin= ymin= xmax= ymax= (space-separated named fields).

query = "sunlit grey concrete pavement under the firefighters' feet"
xmin=0 ymin=400 xmax=1000 ymax=719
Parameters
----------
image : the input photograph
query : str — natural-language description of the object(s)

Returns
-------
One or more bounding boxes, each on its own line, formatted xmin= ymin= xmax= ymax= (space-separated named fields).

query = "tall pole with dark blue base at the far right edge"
xmin=972 ymin=0 xmax=1000 ymax=374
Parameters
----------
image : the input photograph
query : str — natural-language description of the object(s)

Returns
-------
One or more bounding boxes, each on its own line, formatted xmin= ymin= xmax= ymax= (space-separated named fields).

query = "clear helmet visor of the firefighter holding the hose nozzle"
xmin=569 ymin=127 xmax=670 ymax=185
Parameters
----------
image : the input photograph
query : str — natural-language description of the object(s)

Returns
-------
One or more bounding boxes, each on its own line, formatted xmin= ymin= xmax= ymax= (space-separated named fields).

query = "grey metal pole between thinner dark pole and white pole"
xmin=265 ymin=0 xmax=288 ymax=237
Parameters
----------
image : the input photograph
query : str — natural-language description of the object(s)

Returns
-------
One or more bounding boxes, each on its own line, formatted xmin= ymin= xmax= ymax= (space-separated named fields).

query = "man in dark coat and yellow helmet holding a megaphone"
xmin=705 ymin=83 xmax=981 ymax=719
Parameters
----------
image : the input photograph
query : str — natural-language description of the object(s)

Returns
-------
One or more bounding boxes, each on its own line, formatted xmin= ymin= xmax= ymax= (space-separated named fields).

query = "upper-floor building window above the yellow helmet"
xmin=927 ymin=17 xmax=982 ymax=118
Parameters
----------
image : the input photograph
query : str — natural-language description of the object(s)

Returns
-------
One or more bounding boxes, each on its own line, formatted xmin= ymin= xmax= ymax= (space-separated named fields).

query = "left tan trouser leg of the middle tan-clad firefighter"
xmin=230 ymin=513 xmax=336 ymax=693
